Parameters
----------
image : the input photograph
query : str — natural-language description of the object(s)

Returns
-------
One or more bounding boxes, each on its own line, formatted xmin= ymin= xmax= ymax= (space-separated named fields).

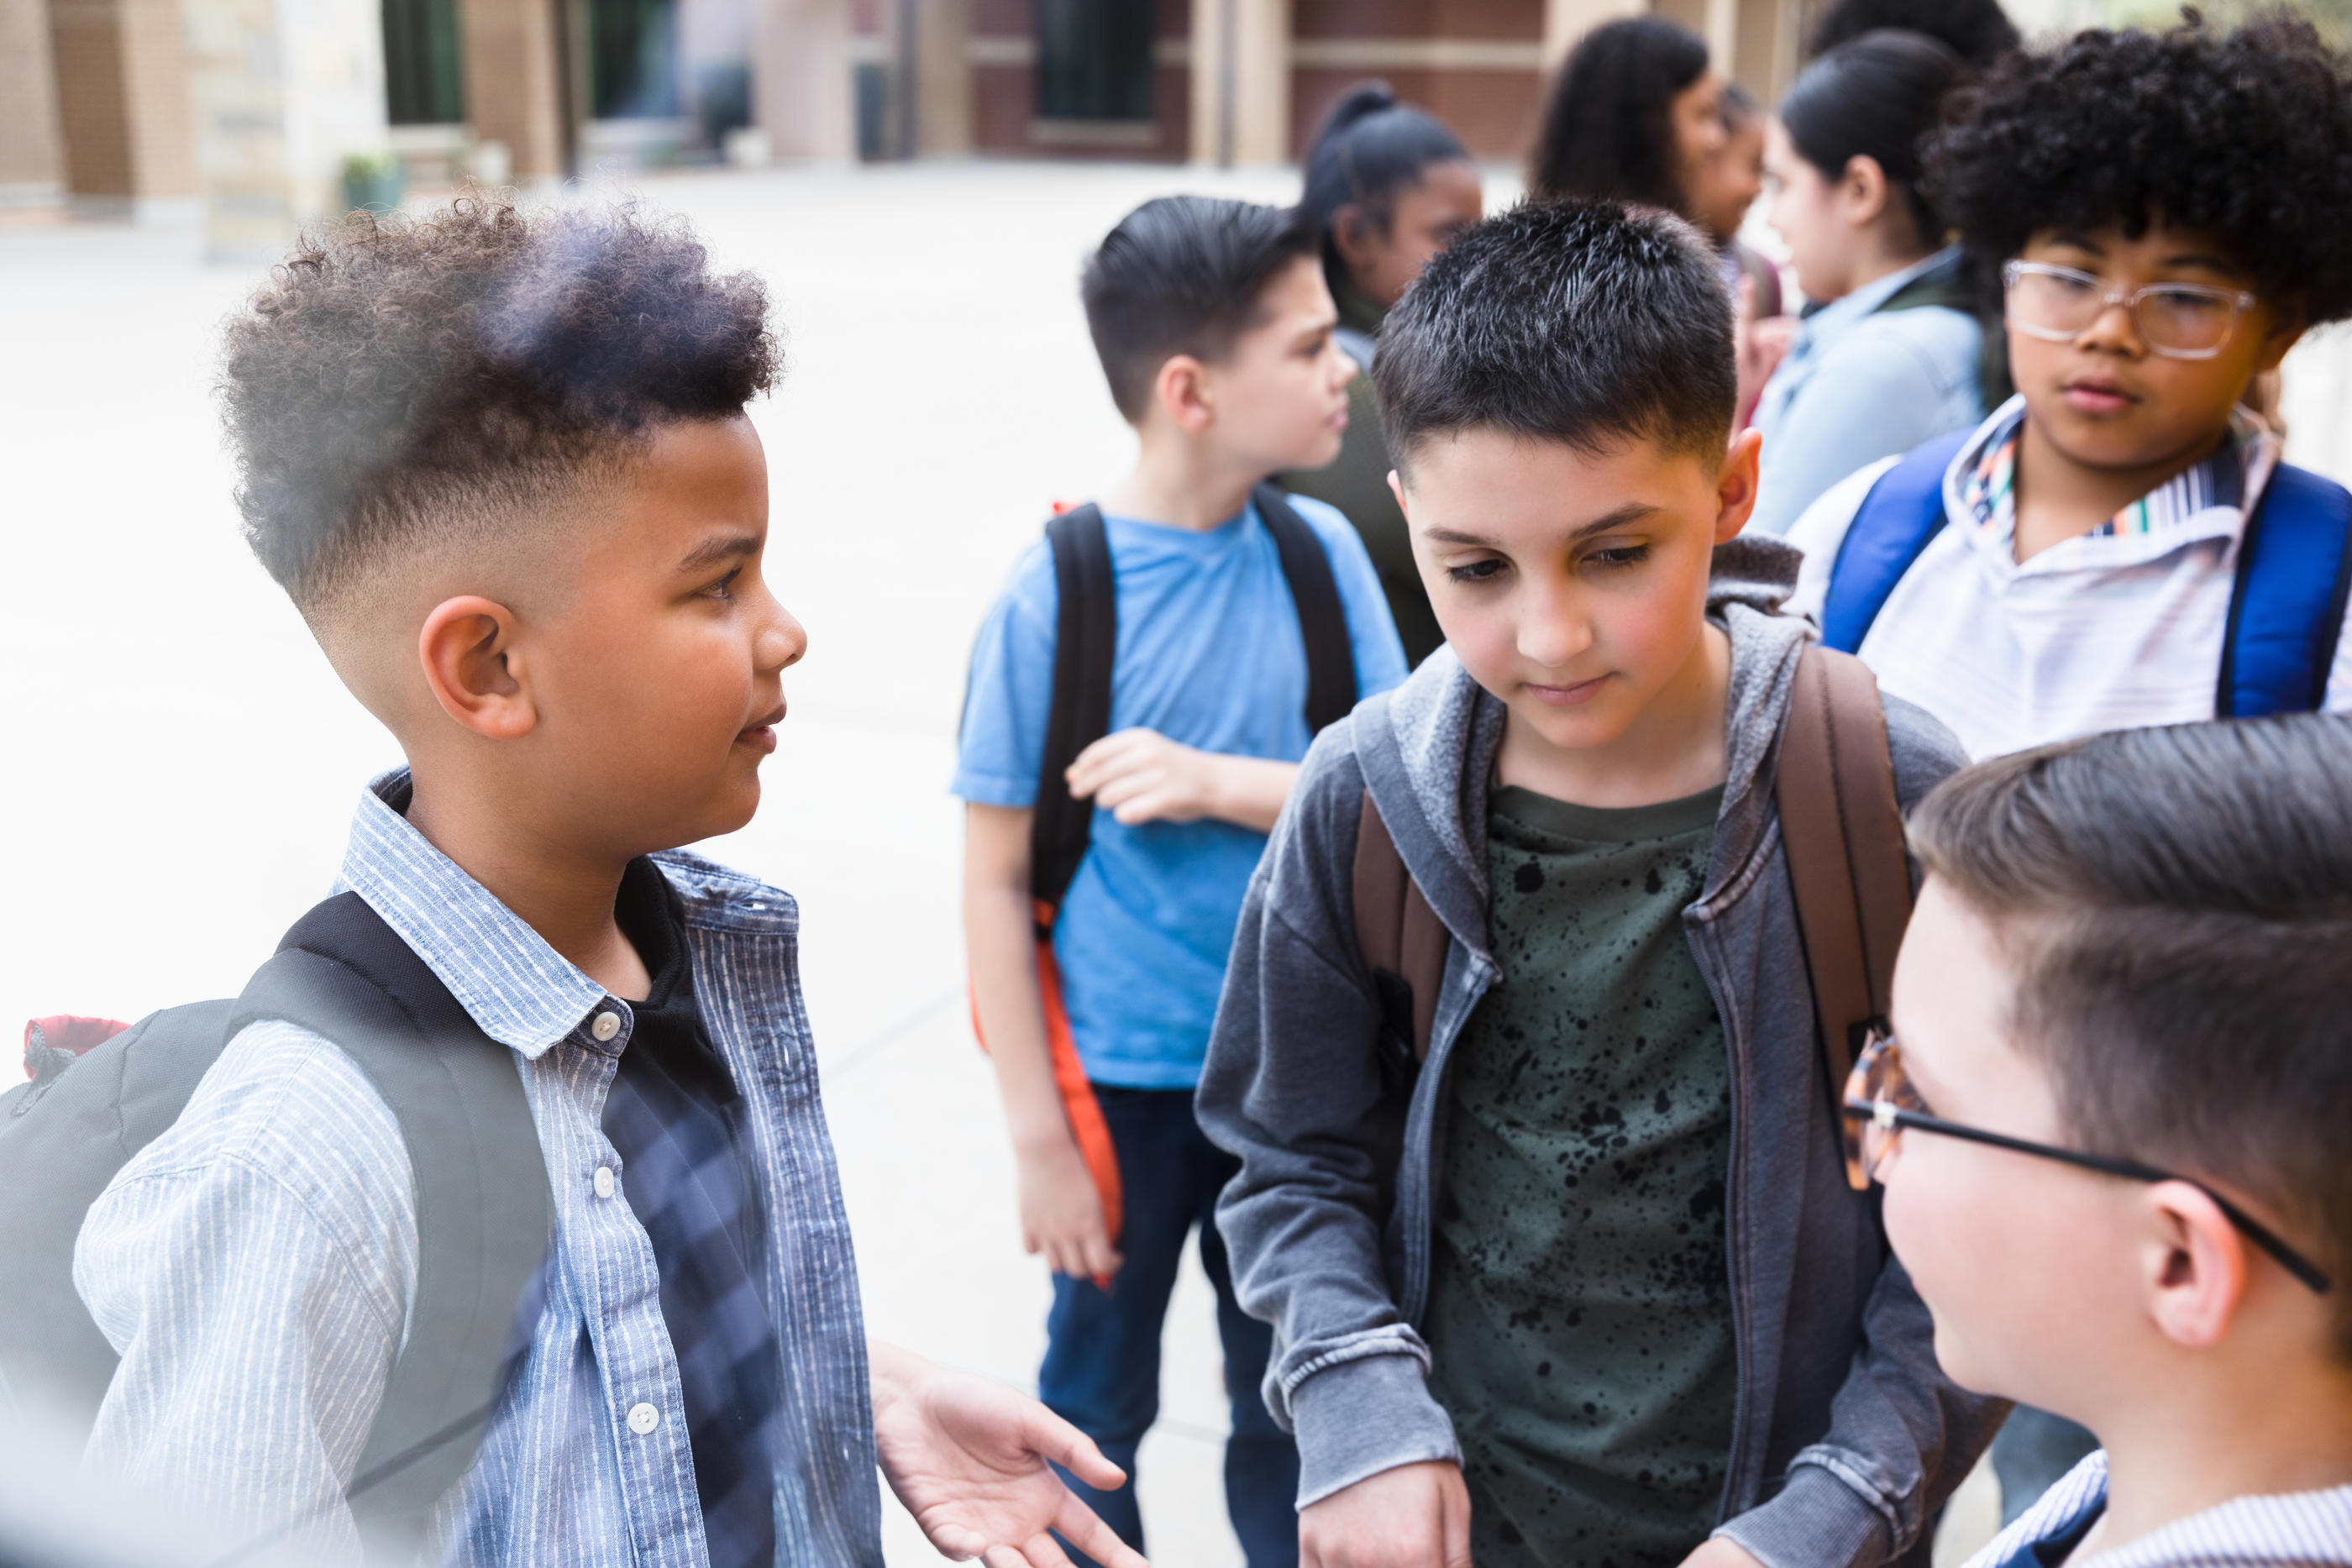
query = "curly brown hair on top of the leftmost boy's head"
xmin=218 ymin=195 xmax=779 ymax=623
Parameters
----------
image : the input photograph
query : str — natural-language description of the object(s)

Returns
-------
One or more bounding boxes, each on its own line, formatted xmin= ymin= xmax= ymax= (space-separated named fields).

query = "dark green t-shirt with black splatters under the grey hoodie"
xmin=1425 ymin=788 xmax=1735 ymax=1568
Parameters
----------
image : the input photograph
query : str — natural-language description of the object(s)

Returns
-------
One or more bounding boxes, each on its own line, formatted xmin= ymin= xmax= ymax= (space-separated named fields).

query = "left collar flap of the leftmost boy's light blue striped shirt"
xmin=336 ymin=768 xmax=628 ymax=1058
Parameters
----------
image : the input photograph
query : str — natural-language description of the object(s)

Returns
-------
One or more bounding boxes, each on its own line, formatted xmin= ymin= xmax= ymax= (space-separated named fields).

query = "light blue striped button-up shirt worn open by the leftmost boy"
xmin=73 ymin=774 xmax=882 ymax=1568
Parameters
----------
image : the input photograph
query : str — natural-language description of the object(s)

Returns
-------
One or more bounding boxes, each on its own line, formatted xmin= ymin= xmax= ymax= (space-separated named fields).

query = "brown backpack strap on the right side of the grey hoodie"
xmin=1776 ymin=644 xmax=1910 ymax=1095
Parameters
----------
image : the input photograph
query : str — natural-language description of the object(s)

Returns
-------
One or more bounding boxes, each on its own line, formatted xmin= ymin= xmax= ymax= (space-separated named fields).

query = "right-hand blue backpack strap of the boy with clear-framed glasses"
xmin=2213 ymin=463 xmax=2352 ymax=720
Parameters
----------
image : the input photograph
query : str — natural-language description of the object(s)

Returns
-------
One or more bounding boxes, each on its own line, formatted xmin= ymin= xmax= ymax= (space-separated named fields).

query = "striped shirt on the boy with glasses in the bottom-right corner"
xmin=1969 ymin=1450 xmax=2352 ymax=1568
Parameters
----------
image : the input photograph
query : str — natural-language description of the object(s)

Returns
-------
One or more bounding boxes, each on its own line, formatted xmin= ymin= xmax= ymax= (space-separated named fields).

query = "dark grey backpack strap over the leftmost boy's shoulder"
xmin=228 ymin=894 xmax=555 ymax=1559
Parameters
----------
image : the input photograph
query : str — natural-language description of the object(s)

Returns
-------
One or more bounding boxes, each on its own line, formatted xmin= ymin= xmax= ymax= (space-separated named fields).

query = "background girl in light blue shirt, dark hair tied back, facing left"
xmin=1747 ymin=30 xmax=1985 ymax=533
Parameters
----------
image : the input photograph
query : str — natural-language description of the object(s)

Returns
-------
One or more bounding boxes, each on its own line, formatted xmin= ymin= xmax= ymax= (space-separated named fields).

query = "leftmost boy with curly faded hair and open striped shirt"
xmin=73 ymin=197 xmax=1143 ymax=1568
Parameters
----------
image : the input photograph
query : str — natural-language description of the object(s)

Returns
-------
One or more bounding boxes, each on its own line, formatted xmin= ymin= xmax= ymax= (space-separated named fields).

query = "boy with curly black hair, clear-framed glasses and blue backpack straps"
xmin=1790 ymin=17 xmax=2352 ymax=757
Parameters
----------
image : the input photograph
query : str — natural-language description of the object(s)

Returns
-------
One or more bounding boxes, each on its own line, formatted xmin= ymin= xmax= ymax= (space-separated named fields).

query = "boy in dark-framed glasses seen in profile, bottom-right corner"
xmin=1844 ymin=715 xmax=2352 ymax=1568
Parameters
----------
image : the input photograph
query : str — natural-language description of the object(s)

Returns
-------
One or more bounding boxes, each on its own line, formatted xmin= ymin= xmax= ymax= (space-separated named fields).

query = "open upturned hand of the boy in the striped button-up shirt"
xmin=870 ymin=1342 xmax=1150 ymax=1568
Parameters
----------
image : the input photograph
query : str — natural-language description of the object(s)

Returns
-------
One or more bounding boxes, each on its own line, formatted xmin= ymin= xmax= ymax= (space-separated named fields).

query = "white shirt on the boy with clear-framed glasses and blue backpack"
xmin=1788 ymin=397 xmax=2352 ymax=759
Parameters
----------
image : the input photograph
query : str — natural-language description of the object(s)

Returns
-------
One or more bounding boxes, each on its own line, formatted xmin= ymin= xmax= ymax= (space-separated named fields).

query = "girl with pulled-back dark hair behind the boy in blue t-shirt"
xmin=1282 ymin=82 xmax=1482 ymax=665
